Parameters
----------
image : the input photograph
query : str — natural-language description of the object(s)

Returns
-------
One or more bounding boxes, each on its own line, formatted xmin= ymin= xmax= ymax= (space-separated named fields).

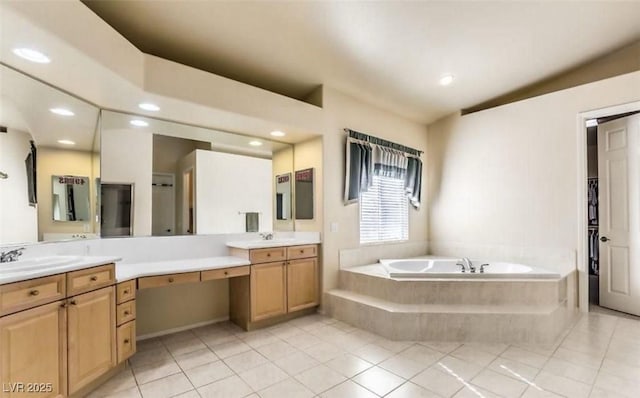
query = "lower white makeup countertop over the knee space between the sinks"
xmin=116 ymin=256 xmax=251 ymax=282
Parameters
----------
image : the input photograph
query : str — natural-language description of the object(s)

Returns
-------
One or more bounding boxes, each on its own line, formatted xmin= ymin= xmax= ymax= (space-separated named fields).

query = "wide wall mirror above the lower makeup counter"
xmin=101 ymin=111 xmax=293 ymax=236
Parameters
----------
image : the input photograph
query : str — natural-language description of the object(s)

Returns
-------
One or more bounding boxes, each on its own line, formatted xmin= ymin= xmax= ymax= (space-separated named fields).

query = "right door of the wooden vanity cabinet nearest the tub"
xmin=287 ymin=257 xmax=318 ymax=312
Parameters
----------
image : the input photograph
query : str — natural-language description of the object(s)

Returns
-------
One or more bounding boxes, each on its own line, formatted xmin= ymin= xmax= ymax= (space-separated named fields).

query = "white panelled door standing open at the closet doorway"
xmin=598 ymin=115 xmax=640 ymax=315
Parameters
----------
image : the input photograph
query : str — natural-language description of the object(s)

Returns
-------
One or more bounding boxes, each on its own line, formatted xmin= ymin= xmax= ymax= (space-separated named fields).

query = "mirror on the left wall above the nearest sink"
xmin=0 ymin=65 xmax=100 ymax=244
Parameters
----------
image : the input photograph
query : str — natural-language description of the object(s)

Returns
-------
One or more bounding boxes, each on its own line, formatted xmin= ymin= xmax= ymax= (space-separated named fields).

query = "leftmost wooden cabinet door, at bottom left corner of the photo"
xmin=0 ymin=301 xmax=67 ymax=398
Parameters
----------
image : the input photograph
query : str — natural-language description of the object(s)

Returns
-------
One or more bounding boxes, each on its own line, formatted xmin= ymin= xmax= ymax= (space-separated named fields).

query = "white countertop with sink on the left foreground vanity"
xmin=0 ymin=256 xmax=121 ymax=285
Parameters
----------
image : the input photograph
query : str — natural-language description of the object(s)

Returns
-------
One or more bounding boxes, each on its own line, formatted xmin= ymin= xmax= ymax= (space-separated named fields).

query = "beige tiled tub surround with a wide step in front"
xmin=324 ymin=264 xmax=578 ymax=343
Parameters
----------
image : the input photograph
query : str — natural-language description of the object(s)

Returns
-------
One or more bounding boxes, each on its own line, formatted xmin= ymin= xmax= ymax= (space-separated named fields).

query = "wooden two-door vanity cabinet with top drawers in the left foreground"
xmin=0 ymin=264 xmax=117 ymax=398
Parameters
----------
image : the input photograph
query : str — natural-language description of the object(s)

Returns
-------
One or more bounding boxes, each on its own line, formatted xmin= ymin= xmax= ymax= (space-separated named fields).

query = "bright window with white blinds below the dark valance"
xmin=360 ymin=175 xmax=409 ymax=243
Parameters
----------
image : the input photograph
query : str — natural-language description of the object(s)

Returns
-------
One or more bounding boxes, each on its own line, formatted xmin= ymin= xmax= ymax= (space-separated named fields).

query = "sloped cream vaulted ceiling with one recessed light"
xmin=84 ymin=1 xmax=640 ymax=123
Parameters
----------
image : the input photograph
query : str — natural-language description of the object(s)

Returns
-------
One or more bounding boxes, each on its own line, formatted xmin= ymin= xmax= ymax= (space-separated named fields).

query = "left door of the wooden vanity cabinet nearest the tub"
xmin=251 ymin=261 xmax=287 ymax=321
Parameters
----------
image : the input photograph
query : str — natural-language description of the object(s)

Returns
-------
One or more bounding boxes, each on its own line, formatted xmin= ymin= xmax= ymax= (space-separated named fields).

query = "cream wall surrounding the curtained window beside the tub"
xmin=320 ymin=87 xmax=428 ymax=291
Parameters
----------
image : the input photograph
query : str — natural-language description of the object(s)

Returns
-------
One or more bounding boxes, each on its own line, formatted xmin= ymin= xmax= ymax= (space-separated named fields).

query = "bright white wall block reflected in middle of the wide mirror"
xmin=196 ymin=150 xmax=273 ymax=234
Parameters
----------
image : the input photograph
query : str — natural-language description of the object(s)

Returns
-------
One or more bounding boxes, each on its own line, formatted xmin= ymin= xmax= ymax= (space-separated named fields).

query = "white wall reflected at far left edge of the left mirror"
xmin=0 ymin=129 xmax=37 ymax=244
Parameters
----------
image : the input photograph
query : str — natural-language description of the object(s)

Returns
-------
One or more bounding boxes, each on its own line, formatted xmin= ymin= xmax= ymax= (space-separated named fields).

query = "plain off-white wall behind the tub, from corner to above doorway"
xmin=427 ymin=72 xmax=640 ymax=274
